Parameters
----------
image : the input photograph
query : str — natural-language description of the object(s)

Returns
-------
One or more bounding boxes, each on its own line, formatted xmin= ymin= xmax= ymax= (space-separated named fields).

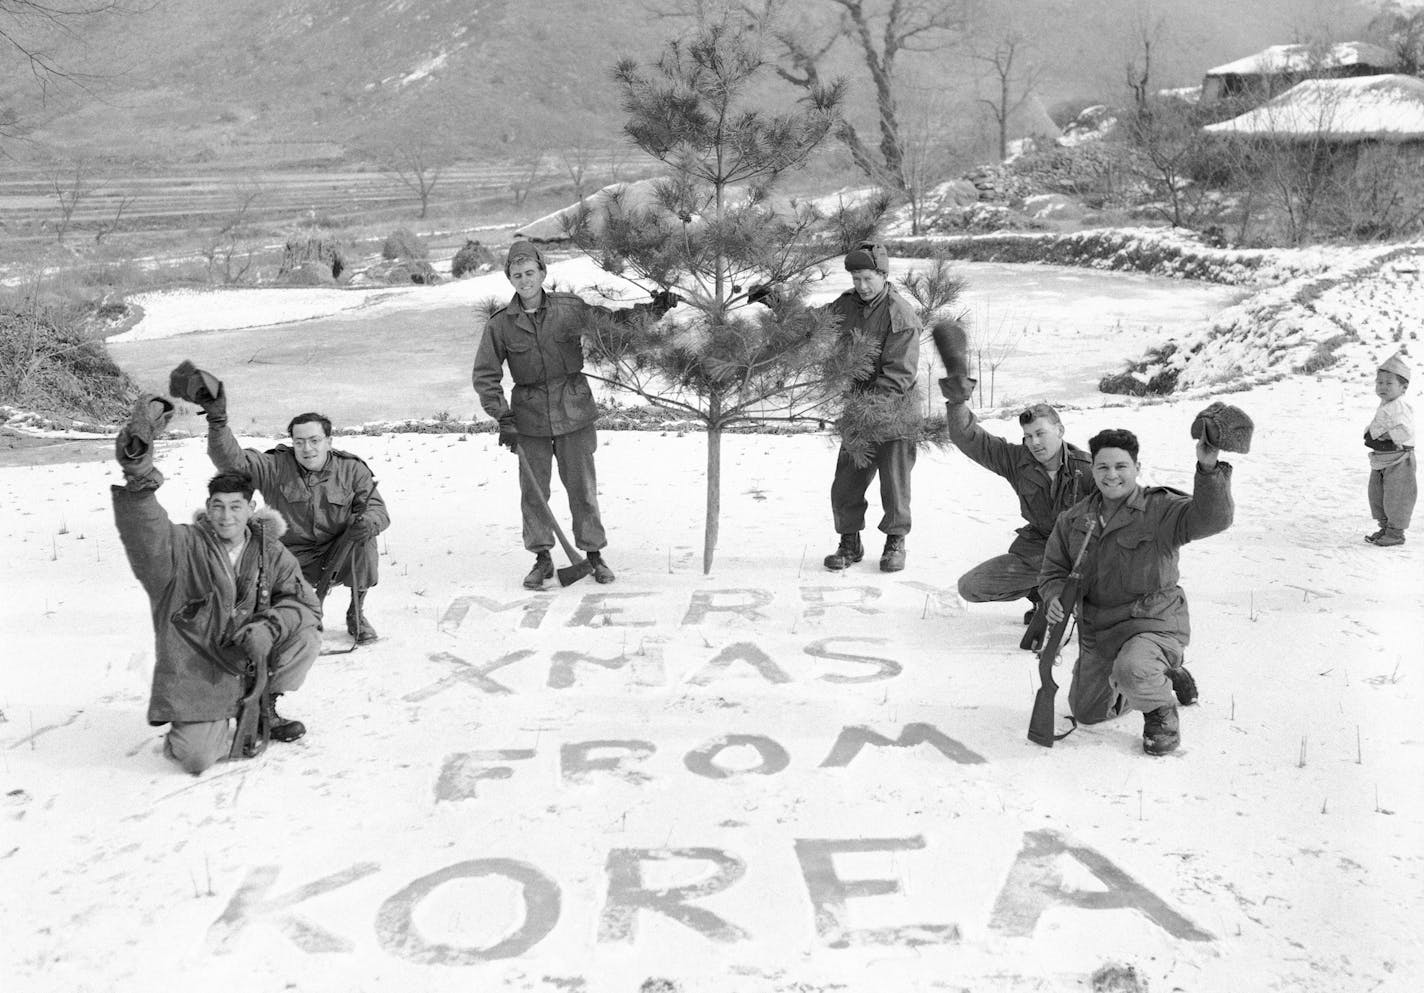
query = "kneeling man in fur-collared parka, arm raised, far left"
xmin=111 ymin=396 xmax=320 ymax=775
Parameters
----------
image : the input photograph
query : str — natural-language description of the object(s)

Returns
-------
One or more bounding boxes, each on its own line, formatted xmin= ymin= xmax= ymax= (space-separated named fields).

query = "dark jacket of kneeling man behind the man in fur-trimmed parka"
xmin=208 ymin=425 xmax=390 ymax=586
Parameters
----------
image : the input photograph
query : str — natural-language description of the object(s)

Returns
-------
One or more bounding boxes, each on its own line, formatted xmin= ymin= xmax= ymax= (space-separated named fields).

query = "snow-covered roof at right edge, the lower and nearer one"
xmin=1205 ymin=76 xmax=1424 ymax=141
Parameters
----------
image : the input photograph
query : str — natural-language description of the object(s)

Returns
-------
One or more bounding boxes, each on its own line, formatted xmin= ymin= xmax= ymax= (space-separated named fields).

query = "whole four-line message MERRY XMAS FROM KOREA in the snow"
xmin=206 ymin=584 xmax=1215 ymax=967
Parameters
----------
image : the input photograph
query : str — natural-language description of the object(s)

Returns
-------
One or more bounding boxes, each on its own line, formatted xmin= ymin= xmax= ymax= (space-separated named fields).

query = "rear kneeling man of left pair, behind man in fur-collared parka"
xmin=169 ymin=362 xmax=390 ymax=644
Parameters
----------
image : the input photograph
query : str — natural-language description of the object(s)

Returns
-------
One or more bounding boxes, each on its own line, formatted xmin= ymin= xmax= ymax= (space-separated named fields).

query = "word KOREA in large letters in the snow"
xmin=208 ymin=831 xmax=1212 ymax=966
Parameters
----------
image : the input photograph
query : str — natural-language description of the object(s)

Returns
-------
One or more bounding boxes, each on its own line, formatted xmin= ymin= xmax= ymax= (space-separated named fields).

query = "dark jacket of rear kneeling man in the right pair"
xmin=946 ymin=403 xmax=1095 ymax=561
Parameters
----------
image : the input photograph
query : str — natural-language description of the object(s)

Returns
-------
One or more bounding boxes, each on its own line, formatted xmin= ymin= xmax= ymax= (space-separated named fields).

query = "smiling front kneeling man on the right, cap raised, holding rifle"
xmin=1038 ymin=429 xmax=1235 ymax=755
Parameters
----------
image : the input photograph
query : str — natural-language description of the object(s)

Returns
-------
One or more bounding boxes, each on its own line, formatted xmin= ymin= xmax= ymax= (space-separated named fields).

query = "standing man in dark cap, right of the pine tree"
xmin=826 ymin=242 xmax=921 ymax=573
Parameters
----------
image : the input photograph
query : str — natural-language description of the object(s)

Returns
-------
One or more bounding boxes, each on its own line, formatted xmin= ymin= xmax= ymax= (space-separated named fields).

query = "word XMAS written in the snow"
xmin=403 ymin=635 xmax=904 ymax=704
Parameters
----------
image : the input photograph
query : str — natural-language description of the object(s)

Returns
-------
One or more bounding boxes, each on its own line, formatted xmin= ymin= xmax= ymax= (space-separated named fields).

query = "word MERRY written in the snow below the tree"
xmin=440 ymin=580 xmax=956 ymax=631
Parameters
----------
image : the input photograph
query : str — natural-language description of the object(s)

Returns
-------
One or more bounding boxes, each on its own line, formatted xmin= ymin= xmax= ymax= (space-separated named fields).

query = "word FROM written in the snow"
xmin=436 ymin=724 xmax=985 ymax=801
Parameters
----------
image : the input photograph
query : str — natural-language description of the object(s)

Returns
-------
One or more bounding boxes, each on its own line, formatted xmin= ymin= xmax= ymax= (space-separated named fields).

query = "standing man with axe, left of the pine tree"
xmin=471 ymin=241 xmax=678 ymax=590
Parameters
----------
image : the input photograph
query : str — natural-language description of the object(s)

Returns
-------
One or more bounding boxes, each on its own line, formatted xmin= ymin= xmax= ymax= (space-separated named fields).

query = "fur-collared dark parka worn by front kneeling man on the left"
xmin=111 ymin=486 xmax=320 ymax=725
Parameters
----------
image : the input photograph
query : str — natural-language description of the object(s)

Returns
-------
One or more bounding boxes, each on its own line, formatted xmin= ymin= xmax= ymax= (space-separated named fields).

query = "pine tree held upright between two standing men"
xmin=570 ymin=23 xmax=887 ymax=573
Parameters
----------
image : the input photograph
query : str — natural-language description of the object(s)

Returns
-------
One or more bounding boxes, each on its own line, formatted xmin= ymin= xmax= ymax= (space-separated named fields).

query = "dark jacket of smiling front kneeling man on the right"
xmin=1038 ymin=462 xmax=1235 ymax=658
